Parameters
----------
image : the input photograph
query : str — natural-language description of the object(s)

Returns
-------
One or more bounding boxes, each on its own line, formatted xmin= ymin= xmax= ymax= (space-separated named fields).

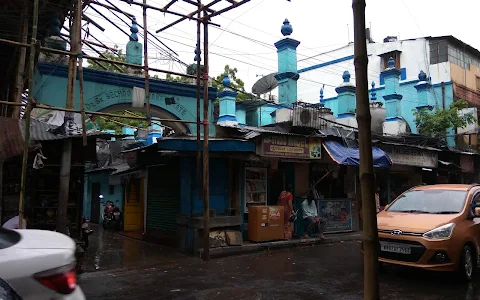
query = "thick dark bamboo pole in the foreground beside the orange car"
xmin=352 ymin=0 xmax=380 ymax=300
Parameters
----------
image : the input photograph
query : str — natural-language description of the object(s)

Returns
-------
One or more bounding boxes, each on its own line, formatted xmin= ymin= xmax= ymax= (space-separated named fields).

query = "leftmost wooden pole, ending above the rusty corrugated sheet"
xmin=12 ymin=0 xmax=29 ymax=119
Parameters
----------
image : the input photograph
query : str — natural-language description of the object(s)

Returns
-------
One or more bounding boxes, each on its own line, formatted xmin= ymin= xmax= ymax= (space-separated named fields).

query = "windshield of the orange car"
xmin=387 ymin=190 xmax=467 ymax=214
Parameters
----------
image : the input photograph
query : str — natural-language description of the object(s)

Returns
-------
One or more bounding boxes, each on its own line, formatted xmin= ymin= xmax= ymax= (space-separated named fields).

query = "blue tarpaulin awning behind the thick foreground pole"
xmin=323 ymin=141 xmax=392 ymax=168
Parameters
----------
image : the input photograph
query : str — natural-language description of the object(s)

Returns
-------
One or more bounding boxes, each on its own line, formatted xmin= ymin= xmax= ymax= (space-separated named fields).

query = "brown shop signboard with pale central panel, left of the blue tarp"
xmin=257 ymin=135 xmax=322 ymax=159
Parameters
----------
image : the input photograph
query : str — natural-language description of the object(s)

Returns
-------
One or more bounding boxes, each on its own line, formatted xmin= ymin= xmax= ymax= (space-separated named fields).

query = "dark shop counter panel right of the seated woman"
xmin=317 ymin=199 xmax=353 ymax=233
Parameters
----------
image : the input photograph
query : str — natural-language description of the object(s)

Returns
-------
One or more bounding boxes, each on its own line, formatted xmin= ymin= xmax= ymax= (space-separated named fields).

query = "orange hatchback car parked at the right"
xmin=377 ymin=184 xmax=480 ymax=280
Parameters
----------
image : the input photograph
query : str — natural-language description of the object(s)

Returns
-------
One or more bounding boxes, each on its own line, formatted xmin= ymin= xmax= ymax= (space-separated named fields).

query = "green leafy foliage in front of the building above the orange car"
xmin=413 ymin=100 xmax=475 ymax=138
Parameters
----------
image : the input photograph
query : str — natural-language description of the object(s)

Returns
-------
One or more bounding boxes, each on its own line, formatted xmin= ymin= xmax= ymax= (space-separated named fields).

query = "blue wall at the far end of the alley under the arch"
xmin=83 ymin=172 xmax=124 ymax=220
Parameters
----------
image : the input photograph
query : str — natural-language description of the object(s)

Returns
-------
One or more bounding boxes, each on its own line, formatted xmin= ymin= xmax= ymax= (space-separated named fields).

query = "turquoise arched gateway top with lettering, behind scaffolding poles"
xmin=33 ymin=63 xmax=217 ymax=136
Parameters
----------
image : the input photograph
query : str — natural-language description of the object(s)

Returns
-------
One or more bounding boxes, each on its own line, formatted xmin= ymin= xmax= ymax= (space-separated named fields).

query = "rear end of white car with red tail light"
xmin=0 ymin=228 xmax=85 ymax=300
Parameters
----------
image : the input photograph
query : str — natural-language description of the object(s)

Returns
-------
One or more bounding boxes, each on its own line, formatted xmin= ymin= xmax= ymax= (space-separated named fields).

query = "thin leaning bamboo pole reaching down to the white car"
xmin=18 ymin=0 xmax=39 ymax=228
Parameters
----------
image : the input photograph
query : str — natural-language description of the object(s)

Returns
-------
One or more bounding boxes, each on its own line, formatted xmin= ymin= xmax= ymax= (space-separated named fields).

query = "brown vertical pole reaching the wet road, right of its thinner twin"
xmin=203 ymin=12 xmax=210 ymax=261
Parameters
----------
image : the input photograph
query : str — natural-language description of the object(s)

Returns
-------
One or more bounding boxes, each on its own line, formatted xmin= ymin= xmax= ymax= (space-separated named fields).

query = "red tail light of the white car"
xmin=34 ymin=265 xmax=77 ymax=295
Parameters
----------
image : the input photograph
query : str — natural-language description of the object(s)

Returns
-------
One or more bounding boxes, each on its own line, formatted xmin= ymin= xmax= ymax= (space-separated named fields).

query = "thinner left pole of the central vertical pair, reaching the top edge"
xmin=192 ymin=0 xmax=203 ymax=220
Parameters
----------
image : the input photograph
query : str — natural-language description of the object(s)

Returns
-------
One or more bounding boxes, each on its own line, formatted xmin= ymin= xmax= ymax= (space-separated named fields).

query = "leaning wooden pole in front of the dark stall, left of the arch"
xmin=56 ymin=0 xmax=82 ymax=233
